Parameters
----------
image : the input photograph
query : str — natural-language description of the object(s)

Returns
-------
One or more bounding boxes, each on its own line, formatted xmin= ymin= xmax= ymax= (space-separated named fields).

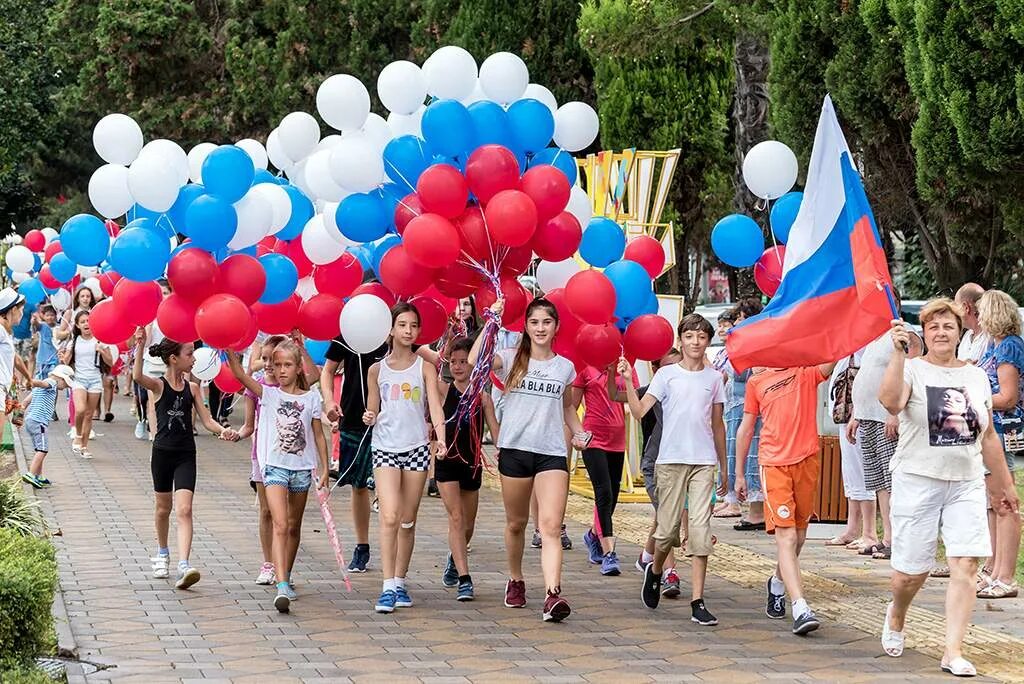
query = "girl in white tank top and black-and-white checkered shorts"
xmin=362 ymin=302 xmax=444 ymax=612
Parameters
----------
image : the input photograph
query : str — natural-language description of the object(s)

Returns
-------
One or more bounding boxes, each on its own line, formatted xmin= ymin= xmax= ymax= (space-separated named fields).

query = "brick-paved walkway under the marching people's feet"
xmin=14 ymin=402 xmax=1024 ymax=684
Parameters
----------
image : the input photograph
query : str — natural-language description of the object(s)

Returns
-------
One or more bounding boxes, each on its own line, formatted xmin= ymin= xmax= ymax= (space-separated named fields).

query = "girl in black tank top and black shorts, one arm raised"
xmin=132 ymin=330 xmax=238 ymax=589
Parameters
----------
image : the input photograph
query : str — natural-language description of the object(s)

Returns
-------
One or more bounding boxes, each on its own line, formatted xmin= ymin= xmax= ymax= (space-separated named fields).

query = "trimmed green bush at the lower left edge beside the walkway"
xmin=0 ymin=527 xmax=57 ymax=670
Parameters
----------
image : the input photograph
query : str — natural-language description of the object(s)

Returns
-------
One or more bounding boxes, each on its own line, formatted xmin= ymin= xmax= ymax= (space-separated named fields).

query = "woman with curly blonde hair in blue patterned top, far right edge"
xmin=978 ymin=290 xmax=1024 ymax=599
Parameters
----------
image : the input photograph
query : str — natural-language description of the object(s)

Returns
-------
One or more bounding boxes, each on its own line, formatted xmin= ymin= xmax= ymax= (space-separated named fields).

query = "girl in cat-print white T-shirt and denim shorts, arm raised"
xmin=227 ymin=342 xmax=328 ymax=612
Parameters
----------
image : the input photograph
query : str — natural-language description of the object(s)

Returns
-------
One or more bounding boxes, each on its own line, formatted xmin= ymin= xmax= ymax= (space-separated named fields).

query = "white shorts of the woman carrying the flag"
xmin=890 ymin=471 xmax=992 ymax=574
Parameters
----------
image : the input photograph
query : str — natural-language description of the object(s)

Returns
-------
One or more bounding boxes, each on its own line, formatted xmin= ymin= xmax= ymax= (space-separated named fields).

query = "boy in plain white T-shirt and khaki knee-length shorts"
xmin=618 ymin=313 xmax=726 ymax=625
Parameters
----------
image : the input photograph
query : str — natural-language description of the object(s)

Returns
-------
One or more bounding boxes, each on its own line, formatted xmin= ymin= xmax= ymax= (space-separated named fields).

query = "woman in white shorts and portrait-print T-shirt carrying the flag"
xmin=879 ymin=298 xmax=1019 ymax=677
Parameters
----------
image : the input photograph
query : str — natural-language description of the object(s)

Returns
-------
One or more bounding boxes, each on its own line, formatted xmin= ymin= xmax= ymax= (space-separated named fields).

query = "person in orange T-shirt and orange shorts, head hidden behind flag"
xmin=736 ymin=364 xmax=836 ymax=635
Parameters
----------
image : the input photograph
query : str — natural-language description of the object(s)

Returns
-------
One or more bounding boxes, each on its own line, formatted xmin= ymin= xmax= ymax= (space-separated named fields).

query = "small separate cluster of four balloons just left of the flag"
xmin=711 ymin=140 xmax=804 ymax=297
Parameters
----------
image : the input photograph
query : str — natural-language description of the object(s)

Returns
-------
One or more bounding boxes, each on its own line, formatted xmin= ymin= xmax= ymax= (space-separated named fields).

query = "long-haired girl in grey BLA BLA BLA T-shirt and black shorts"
xmin=469 ymin=298 xmax=591 ymax=623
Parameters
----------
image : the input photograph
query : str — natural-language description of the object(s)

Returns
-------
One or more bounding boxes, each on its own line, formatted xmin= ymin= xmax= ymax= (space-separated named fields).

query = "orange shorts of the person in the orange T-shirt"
xmin=761 ymin=454 xmax=821 ymax=535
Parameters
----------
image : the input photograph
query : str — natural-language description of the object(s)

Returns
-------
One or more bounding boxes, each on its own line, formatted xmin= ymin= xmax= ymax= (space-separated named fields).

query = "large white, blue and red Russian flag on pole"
xmin=725 ymin=96 xmax=893 ymax=372
